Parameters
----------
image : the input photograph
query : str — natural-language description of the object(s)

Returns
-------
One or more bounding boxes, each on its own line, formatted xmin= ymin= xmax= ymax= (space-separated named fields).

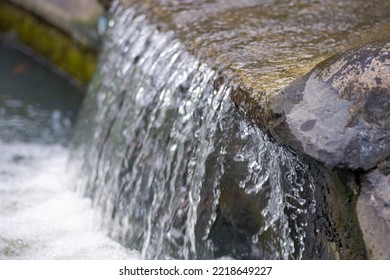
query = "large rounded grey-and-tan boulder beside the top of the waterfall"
xmin=271 ymin=39 xmax=390 ymax=170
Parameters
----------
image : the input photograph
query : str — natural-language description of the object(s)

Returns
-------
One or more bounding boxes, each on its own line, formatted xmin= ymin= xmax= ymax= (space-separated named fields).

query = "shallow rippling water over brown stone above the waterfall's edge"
xmin=120 ymin=0 xmax=390 ymax=101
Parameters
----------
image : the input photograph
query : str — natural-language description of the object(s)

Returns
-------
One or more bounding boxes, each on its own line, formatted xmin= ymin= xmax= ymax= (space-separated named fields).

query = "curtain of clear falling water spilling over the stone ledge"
xmin=71 ymin=4 xmax=321 ymax=259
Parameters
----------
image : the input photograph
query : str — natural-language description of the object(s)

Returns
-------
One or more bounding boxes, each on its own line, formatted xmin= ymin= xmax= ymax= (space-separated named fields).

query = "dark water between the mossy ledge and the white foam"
xmin=0 ymin=44 xmax=82 ymax=145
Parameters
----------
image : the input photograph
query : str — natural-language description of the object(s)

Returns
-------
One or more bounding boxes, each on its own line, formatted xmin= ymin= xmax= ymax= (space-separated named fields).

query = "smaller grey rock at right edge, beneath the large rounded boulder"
xmin=357 ymin=167 xmax=390 ymax=259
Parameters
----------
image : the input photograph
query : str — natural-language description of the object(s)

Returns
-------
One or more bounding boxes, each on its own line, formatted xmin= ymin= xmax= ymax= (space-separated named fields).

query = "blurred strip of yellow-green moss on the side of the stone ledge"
xmin=0 ymin=3 xmax=96 ymax=84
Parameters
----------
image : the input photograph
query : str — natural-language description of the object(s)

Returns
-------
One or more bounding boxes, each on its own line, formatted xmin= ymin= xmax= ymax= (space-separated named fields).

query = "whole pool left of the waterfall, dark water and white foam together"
xmin=0 ymin=41 xmax=138 ymax=259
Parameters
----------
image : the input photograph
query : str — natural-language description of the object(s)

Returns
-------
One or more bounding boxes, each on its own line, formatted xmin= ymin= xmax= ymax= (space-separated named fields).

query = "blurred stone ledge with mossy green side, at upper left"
xmin=0 ymin=0 xmax=107 ymax=86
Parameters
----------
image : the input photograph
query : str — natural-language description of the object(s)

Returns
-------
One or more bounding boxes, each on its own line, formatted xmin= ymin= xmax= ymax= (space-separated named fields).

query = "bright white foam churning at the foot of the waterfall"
xmin=0 ymin=142 xmax=139 ymax=259
